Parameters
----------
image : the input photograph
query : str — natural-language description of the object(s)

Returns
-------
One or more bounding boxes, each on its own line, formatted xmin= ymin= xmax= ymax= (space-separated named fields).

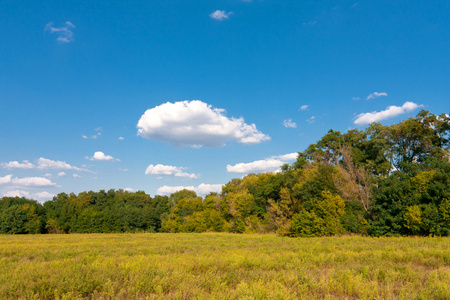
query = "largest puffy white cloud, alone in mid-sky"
xmin=137 ymin=100 xmax=270 ymax=148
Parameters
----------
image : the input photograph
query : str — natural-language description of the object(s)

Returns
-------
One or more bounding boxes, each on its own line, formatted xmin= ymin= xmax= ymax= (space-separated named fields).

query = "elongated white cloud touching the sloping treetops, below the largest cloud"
xmin=227 ymin=153 xmax=298 ymax=174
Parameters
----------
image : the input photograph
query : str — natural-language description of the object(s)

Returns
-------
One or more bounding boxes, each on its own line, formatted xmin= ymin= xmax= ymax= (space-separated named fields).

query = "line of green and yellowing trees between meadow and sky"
xmin=0 ymin=110 xmax=450 ymax=237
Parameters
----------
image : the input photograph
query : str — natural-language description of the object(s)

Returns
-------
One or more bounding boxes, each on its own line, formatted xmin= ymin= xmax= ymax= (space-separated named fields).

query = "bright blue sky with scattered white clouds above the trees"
xmin=0 ymin=0 xmax=450 ymax=201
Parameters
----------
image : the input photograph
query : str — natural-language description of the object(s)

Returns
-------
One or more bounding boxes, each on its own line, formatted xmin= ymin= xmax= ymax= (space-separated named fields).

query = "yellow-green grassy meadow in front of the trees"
xmin=0 ymin=233 xmax=450 ymax=299
